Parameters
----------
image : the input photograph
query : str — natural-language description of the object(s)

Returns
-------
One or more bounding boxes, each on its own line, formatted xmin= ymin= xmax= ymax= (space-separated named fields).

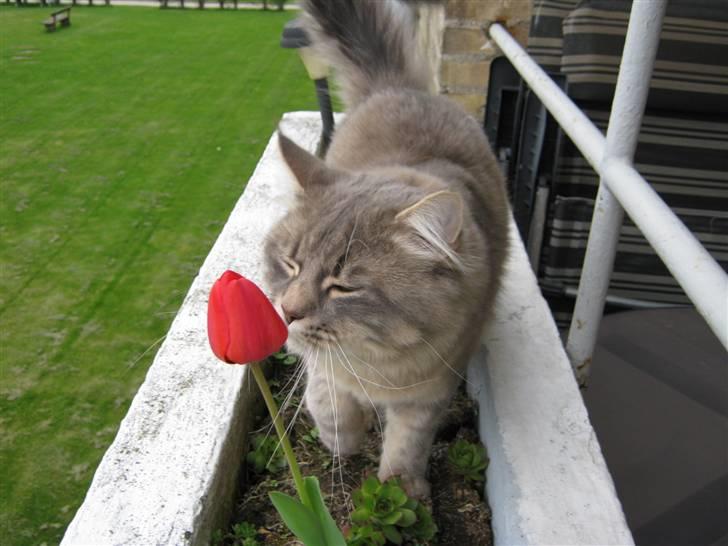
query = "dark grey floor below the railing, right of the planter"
xmin=583 ymin=309 xmax=728 ymax=546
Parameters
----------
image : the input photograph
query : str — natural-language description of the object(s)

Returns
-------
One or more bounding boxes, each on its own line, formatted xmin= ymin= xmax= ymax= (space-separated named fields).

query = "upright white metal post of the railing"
xmin=566 ymin=0 xmax=667 ymax=385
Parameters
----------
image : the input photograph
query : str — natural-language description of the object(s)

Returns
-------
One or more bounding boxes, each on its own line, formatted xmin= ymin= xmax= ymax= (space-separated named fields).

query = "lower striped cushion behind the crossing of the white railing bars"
xmin=541 ymin=107 xmax=728 ymax=310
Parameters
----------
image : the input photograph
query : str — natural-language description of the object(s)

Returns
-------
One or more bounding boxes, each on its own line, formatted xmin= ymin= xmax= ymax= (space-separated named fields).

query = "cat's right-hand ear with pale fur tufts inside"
xmin=395 ymin=190 xmax=464 ymax=261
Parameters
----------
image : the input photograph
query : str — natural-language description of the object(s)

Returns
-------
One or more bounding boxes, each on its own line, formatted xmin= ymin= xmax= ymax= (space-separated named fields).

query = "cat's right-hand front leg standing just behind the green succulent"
xmin=378 ymin=404 xmax=444 ymax=498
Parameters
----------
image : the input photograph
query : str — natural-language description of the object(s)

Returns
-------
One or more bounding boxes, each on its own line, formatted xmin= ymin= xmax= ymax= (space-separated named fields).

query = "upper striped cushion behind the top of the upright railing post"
xmin=564 ymin=0 xmax=728 ymax=113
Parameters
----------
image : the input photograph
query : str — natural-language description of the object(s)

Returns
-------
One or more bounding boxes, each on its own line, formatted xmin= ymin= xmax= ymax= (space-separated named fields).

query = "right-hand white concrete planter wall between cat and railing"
xmin=468 ymin=222 xmax=634 ymax=546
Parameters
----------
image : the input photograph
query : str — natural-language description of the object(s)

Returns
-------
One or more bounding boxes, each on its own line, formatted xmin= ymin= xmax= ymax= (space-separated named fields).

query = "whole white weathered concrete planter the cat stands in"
xmin=62 ymin=112 xmax=632 ymax=546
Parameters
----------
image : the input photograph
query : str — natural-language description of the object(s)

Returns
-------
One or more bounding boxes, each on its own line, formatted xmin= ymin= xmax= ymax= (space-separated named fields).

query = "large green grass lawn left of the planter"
xmin=0 ymin=7 xmax=316 ymax=545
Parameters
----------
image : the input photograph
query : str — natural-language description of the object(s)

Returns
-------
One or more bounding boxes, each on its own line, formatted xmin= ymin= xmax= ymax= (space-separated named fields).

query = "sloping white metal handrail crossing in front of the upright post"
xmin=488 ymin=21 xmax=728 ymax=370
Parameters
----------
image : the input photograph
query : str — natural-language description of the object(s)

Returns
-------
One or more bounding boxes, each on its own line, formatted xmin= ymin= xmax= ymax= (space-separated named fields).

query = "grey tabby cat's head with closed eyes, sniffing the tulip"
xmin=265 ymin=135 xmax=468 ymax=360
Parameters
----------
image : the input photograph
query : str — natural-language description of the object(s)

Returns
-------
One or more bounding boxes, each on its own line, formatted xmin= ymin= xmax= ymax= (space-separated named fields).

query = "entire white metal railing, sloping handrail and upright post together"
xmin=488 ymin=0 xmax=728 ymax=384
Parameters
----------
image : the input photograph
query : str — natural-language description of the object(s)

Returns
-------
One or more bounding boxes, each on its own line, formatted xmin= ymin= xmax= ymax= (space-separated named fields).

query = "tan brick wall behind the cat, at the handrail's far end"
xmin=439 ymin=0 xmax=531 ymax=119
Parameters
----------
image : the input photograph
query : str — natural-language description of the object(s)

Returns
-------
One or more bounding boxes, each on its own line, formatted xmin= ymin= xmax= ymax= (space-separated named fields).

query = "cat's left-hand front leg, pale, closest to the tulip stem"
xmin=305 ymin=370 xmax=371 ymax=456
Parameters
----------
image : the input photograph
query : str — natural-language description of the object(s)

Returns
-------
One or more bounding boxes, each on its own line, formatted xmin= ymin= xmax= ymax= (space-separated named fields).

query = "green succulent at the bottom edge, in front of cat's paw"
xmin=349 ymin=477 xmax=437 ymax=545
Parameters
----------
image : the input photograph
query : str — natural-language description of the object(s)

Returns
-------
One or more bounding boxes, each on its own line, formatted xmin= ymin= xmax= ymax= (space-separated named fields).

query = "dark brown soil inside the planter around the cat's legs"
xmin=223 ymin=356 xmax=493 ymax=546
